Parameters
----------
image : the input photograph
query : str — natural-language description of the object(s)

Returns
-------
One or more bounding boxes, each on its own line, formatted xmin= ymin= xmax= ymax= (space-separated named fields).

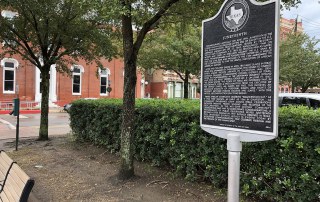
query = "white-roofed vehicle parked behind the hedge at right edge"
xmin=279 ymin=93 xmax=320 ymax=109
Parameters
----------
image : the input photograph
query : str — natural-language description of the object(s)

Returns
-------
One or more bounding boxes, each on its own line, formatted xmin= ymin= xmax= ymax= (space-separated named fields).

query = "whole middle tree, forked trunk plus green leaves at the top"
xmin=91 ymin=0 xmax=299 ymax=179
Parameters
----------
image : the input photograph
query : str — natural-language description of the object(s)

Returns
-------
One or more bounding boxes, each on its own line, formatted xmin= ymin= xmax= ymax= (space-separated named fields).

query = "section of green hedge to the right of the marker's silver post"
xmin=241 ymin=107 xmax=320 ymax=201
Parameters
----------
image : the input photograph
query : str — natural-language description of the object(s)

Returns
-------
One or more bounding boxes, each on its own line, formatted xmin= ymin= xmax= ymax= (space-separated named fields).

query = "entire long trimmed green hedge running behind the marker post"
xmin=70 ymin=99 xmax=320 ymax=201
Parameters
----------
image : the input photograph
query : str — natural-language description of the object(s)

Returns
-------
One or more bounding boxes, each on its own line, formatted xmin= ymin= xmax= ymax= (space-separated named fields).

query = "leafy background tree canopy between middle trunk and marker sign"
xmin=138 ymin=24 xmax=201 ymax=75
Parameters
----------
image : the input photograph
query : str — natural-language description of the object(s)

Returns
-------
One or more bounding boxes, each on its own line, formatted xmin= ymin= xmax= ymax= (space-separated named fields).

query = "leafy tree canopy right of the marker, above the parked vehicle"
xmin=280 ymin=33 xmax=320 ymax=92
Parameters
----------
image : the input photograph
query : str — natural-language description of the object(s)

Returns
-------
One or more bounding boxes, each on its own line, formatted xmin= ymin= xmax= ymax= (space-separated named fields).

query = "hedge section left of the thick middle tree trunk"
xmin=70 ymin=99 xmax=122 ymax=151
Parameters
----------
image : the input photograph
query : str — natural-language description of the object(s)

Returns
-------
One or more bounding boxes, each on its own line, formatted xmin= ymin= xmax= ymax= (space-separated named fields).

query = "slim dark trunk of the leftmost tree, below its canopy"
xmin=38 ymin=66 xmax=50 ymax=140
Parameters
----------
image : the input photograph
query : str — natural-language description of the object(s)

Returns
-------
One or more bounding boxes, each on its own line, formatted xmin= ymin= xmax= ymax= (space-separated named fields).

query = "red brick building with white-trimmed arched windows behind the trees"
xmin=0 ymin=51 xmax=145 ymax=106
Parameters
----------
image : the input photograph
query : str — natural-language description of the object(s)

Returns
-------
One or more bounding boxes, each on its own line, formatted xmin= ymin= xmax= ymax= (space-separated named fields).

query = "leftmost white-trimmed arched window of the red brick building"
xmin=1 ymin=58 xmax=19 ymax=94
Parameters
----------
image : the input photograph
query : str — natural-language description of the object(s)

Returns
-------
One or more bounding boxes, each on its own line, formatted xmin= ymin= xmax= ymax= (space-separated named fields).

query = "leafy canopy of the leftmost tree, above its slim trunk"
xmin=0 ymin=0 xmax=114 ymax=71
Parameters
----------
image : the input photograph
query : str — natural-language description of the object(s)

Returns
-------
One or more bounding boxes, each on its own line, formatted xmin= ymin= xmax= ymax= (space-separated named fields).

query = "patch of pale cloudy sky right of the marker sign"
xmin=281 ymin=0 xmax=320 ymax=39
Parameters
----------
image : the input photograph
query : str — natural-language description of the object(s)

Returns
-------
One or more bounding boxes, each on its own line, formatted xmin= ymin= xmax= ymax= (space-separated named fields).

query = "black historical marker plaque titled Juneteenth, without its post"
xmin=201 ymin=0 xmax=279 ymax=142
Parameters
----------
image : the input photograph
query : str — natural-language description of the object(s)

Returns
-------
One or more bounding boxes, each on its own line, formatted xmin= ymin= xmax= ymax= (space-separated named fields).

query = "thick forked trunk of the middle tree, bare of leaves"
xmin=118 ymin=0 xmax=179 ymax=180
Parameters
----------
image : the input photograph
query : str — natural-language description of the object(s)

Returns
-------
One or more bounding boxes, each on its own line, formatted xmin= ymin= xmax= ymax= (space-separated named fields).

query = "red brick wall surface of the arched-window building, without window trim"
xmin=0 ymin=52 xmax=142 ymax=106
